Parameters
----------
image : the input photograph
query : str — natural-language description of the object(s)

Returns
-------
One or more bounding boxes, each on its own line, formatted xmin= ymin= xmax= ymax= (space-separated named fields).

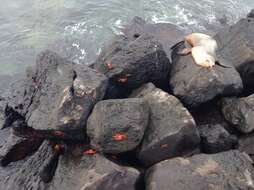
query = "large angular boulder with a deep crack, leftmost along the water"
xmin=4 ymin=51 xmax=107 ymax=130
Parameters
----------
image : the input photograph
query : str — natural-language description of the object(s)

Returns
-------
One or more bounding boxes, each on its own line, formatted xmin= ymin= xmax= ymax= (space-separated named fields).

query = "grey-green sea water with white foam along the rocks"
xmin=0 ymin=0 xmax=254 ymax=75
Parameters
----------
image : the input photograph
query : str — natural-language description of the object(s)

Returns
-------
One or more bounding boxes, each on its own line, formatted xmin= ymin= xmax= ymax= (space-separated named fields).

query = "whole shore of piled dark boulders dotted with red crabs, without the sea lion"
xmin=0 ymin=8 xmax=254 ymax=190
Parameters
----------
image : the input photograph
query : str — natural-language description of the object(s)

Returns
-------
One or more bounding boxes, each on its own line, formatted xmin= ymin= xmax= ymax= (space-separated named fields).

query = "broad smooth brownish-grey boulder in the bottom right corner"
xmin=146 ymin=151 xmax=254 ymax=190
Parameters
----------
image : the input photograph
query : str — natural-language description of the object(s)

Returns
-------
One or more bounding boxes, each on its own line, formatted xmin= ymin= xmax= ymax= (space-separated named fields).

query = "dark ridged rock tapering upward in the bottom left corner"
xmin=0 ymin=142 xmax=52 ymax=190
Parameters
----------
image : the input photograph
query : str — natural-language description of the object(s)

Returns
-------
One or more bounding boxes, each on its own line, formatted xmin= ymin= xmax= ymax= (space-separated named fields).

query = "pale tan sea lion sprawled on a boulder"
xmin=171 ymin=33 xmax=229 ymax=68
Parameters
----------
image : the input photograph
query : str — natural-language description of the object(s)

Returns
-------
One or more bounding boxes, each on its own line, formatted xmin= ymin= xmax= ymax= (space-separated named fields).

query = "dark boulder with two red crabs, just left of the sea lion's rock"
xmin=93 ymin=34 xmax=170 ymax=89
